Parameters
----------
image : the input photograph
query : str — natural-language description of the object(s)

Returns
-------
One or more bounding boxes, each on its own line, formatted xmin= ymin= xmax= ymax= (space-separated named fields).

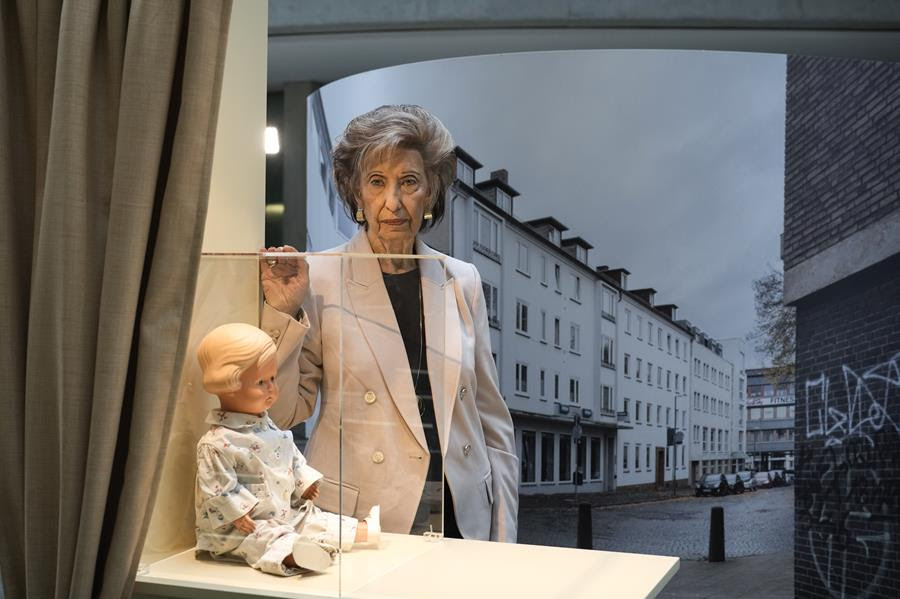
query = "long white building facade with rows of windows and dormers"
xmin=426 ymin=148 xmax=743 ymax=494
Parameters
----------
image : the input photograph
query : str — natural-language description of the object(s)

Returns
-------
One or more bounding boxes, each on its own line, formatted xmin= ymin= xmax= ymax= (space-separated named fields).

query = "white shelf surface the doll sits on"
xmin=134 ymin=533 xmax=678 ymax=599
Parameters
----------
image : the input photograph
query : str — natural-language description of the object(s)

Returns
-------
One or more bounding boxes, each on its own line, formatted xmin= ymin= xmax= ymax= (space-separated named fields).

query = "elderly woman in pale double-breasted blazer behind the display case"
xmin=260 ymin=106 xmax=518 ymax=542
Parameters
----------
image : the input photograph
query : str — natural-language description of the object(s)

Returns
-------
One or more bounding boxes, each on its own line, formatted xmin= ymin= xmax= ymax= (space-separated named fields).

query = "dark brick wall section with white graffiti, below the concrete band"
xmin=794 ymin=255 xmax=900 ymax=598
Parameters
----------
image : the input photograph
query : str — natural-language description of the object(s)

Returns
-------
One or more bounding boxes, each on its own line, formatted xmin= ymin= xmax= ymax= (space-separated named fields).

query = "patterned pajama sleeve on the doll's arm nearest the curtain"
xmin=197 ymin=444 xmax=259 ymax=530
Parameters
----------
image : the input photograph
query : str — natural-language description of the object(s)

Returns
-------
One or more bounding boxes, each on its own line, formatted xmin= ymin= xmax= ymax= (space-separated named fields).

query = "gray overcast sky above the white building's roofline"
xmin=322 ymin=50 xmax=785 ymax=367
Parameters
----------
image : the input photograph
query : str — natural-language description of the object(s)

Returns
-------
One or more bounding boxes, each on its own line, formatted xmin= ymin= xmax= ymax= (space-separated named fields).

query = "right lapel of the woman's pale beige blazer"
xmin=416 ymin=241 xmax=462 ymax=456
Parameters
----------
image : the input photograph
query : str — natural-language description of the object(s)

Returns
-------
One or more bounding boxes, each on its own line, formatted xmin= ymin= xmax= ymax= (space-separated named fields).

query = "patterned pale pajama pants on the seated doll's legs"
xmin=214 ymin=501 xmax=357 ymax=576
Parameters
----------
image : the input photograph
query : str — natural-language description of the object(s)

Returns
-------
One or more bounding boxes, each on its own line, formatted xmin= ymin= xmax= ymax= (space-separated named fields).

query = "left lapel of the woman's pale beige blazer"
xmin=345 ymin=230 xmax=428 ymax=449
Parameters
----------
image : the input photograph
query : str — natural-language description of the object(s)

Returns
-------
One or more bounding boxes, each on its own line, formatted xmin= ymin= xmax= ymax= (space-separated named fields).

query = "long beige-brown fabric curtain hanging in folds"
xmin=0 ymin=0 xmax=231 ymax=598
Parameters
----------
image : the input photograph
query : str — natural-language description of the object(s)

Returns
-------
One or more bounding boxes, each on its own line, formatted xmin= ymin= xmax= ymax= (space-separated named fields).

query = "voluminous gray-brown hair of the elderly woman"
xmin=331 ymin=104 xmax=456 ymax=228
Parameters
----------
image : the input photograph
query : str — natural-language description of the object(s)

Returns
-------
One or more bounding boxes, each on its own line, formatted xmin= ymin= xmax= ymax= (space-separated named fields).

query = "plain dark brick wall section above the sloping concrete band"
xmin=783 ymin=56 xmax=900 ymax=269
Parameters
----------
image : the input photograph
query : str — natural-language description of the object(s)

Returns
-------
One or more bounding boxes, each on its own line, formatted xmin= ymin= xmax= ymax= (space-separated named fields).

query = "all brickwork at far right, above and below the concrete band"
xmin=783 ymin=57 xmax=900 ymax=598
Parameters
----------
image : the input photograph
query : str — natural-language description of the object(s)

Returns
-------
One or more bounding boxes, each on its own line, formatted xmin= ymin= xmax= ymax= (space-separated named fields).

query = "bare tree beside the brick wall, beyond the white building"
xmin=747 ymin=265 xmax=797 ymax=382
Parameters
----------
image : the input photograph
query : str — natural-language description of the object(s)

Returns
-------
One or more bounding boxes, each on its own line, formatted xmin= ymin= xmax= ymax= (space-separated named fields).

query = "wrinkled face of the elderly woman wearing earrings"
xmin=359 ymin=148 xmax=431 ymax=253
